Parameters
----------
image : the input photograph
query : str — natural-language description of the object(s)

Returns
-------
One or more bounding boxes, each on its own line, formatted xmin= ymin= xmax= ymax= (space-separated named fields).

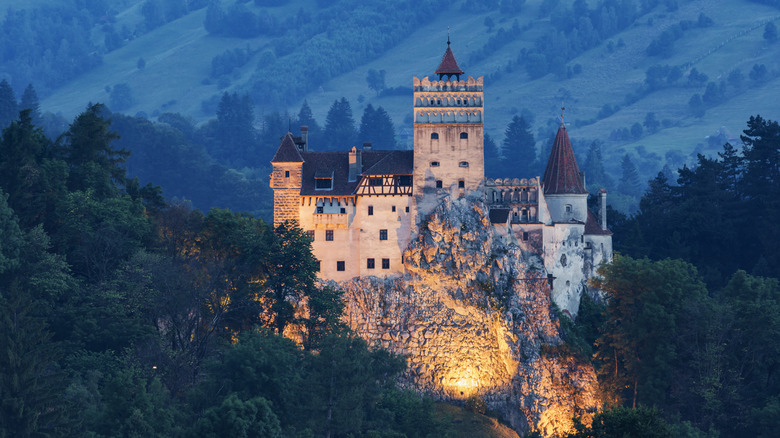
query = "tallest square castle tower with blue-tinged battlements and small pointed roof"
xmin=414 ymin=38 xmax=485 ymax=215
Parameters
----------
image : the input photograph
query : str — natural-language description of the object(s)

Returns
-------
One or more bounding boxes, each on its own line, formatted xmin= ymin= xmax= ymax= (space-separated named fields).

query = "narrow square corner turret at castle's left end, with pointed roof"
xmin=271 ymin=132 xmax=303 ymax=225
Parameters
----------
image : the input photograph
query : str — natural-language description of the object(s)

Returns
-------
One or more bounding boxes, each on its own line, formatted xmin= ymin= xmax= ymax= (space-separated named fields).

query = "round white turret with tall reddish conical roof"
xmin=542 ymin=116 xmax=588 ymax=224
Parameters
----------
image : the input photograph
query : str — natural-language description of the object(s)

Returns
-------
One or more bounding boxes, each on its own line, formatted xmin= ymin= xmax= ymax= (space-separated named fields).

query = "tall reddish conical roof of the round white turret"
xmin=542 ymin=123 xmax=588 ymax=195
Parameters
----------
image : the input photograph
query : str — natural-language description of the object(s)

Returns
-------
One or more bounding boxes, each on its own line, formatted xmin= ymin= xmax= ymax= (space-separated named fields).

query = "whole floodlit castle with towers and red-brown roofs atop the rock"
xmin=270 ymin=41 xmax=612 ymax=314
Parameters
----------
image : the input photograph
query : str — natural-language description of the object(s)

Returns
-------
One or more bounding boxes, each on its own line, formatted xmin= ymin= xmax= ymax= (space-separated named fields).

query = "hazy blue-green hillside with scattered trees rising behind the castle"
xmin=7 ymin=0 xmax=780 ymax=207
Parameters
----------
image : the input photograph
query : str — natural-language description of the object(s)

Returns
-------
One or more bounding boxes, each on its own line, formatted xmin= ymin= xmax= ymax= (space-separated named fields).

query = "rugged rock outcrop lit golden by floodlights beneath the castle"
xmin=340 ymin=193 xmax=596 ymax=436
